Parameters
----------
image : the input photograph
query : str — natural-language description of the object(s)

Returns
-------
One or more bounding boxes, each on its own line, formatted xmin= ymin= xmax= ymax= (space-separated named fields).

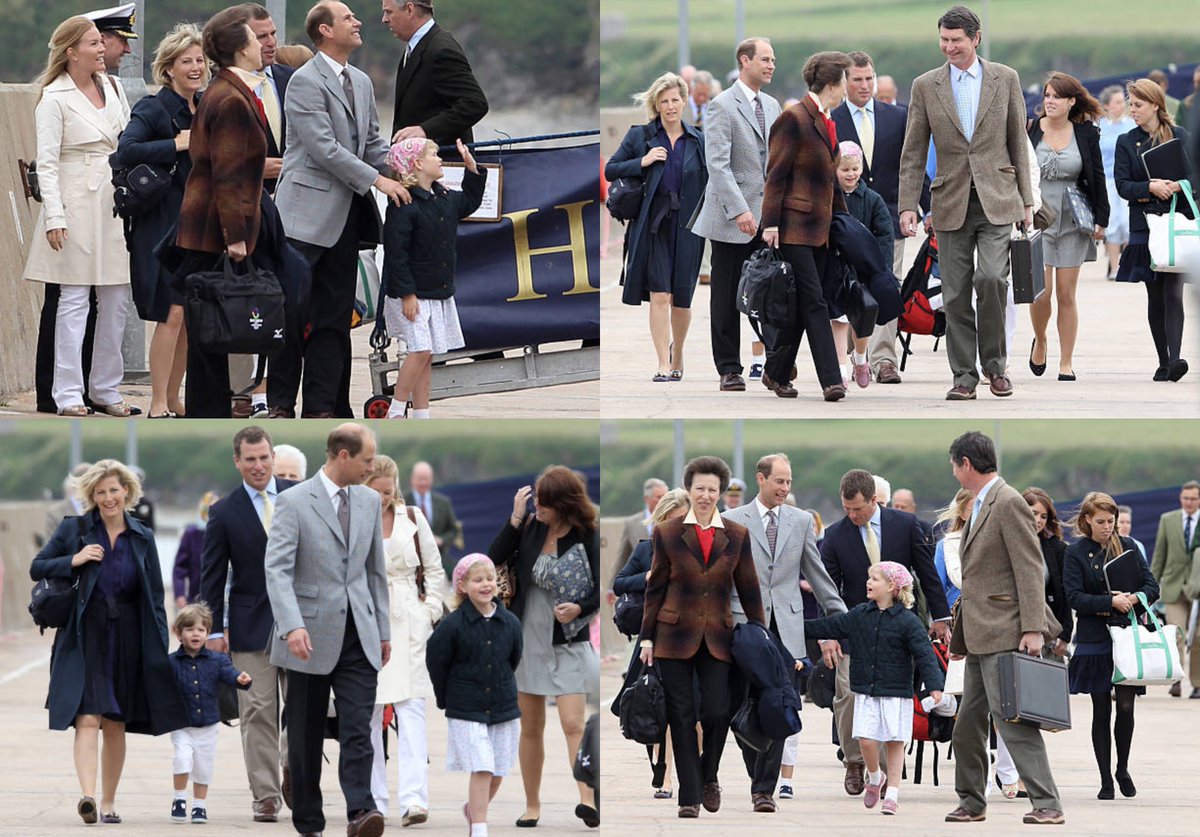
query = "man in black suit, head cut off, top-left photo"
xmin=383 ymin=0 xmax=487 ymax=146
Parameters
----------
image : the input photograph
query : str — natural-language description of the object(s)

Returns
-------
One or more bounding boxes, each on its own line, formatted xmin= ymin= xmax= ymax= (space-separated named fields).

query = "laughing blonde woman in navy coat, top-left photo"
xmin=116 ymin=23 xmax=209 ymax=419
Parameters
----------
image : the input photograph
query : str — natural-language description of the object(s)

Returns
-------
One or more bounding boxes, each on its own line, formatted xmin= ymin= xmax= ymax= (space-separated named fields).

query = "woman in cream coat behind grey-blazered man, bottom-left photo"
xmin=366 ymin=456 xmax=445 ymax=825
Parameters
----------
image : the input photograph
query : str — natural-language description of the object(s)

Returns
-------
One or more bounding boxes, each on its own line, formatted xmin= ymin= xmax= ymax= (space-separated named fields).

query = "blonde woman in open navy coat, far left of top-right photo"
xmin=604 ymin=73 xmax=708 ymax=383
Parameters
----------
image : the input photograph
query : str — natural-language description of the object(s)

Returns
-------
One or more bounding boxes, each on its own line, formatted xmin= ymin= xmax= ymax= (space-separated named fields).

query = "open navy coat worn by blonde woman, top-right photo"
xmin=604 ymin=119 xmax=708 ymax=305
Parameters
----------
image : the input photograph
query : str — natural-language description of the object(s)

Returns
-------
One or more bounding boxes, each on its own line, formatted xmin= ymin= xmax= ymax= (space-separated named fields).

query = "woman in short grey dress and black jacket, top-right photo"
xmin=1030 ymin=73 xmax=1109 ymax=381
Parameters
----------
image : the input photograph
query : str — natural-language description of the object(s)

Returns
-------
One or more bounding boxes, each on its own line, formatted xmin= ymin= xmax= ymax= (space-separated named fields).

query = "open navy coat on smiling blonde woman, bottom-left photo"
xmin=29 ymin=510 xmax=187 ymax=735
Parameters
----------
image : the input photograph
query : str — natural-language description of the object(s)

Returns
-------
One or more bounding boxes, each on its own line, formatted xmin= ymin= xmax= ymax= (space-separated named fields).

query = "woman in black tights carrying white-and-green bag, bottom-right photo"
xmin=1063 ymin=492 xmax=1158 ymax=799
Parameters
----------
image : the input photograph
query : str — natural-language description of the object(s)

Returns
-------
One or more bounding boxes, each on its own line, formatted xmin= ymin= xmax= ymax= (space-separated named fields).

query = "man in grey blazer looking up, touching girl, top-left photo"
xmin=268 ymin=2 xmax=409 ymax=419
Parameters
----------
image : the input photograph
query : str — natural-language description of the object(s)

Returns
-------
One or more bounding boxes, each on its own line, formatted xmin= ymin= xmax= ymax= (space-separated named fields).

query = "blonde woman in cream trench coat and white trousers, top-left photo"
xmin=24 ymin=18 xmax=130 ymax=417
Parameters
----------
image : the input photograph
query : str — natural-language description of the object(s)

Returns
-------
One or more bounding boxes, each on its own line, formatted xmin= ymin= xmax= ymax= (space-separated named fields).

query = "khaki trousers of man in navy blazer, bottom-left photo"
xmin=230 ymin=651 xmax=288 ymax=808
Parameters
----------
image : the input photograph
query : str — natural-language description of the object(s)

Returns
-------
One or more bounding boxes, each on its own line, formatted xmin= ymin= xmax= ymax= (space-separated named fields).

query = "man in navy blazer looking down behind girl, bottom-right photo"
xmin=821 ymin=469 xmax=950 ymax=796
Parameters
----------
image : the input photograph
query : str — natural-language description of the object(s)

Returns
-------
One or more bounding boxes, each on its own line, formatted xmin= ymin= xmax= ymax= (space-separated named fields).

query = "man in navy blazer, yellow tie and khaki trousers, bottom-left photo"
xmin=200 ymin=426 xmax=295 ymax=823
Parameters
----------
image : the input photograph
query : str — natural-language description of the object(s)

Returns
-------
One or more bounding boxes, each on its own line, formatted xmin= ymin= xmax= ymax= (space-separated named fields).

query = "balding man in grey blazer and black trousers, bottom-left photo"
xmin=265 ymin=424 xmax=391 ymax=837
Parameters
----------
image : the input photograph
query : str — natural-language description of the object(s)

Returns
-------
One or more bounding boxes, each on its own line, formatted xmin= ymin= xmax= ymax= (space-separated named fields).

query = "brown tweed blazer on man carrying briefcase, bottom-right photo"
xmin=950 ymin=478 xmax=1062 ymax=654
